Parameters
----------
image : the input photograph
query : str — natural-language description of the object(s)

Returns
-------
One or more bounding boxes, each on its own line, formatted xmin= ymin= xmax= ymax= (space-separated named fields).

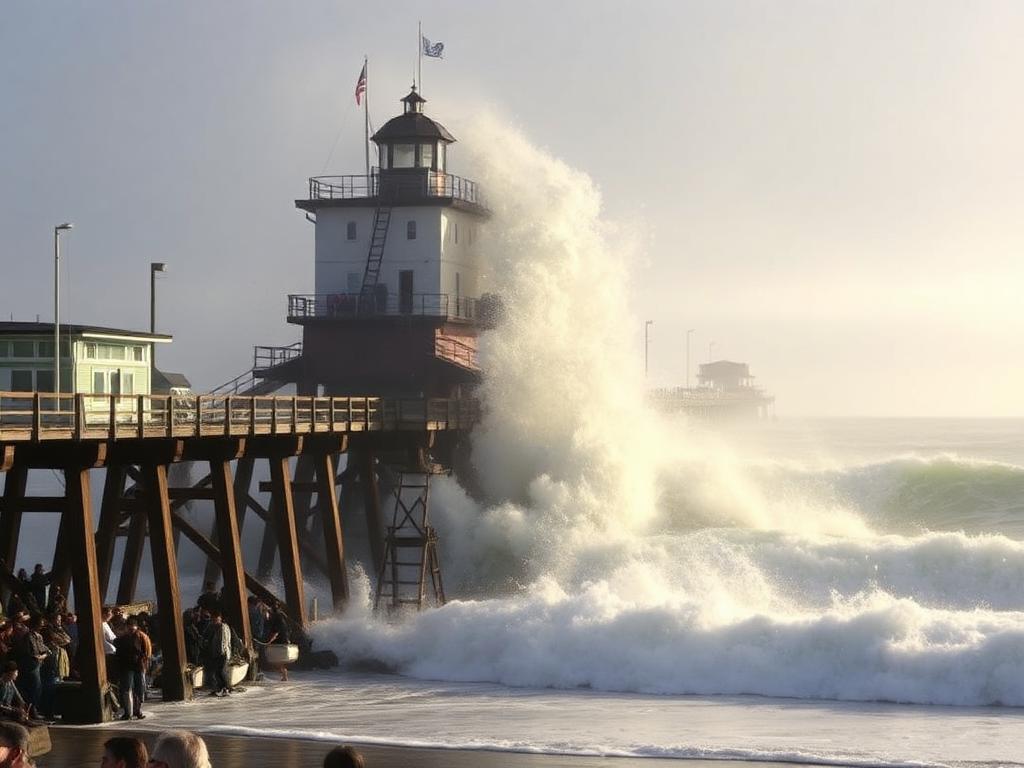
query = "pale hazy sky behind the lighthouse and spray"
xmin=0 ymin=0 xmax=1024 ymax=416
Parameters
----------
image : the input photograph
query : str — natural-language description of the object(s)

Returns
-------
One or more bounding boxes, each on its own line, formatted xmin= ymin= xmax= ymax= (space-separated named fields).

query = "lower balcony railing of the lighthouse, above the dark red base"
xmin=288 ymin=286 xmax=479 ymax=323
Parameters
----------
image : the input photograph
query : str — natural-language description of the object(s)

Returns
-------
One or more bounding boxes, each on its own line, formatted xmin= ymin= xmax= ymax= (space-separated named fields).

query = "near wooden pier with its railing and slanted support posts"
xmin=0 ymin=392 xmax=477 ymax=722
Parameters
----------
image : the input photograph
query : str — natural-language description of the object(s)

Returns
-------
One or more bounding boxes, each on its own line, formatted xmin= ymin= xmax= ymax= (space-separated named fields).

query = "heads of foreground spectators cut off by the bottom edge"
xmin=0 ymin=722 xmax=366 ymax=768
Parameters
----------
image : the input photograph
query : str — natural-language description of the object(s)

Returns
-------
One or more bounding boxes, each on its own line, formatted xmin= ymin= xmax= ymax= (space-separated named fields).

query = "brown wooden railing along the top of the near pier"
xmin=0 ymin=392 xmax=478 ymax=442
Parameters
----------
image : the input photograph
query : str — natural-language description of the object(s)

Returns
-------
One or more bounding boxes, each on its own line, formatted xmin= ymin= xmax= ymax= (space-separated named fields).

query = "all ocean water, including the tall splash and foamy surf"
xmin=18 ymin=119 xmax=1024 ymax=765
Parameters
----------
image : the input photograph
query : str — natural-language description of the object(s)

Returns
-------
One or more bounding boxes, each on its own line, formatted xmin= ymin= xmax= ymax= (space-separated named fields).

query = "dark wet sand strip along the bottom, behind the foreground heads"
xmin=36 ymin=726 xmax=751 ymax=768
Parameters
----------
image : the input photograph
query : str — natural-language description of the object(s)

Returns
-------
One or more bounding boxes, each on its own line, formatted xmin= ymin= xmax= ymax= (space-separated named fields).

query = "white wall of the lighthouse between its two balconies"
xmin=314 ymin=206 xmax=445 ymax=296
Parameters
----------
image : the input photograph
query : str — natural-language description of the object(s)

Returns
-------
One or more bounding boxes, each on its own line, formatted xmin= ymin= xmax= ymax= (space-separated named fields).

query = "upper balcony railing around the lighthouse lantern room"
xmin=309 ymin=168 xmax=486 ymax=207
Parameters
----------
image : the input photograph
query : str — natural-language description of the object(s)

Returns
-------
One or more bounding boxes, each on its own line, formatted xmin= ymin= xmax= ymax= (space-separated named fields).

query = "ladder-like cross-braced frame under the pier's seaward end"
xmin=374 ymin=466 xmax=445 ymax=611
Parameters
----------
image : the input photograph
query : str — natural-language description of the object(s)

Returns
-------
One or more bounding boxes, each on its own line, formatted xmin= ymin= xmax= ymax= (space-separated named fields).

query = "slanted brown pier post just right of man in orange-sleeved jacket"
xmin=142 ymin=464 xmax=193 ymax=701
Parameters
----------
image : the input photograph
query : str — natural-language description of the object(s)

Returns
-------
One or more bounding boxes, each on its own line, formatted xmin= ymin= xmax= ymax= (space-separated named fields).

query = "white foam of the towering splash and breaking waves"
xmin=305 ymin=114 xmax=1024 ymax=706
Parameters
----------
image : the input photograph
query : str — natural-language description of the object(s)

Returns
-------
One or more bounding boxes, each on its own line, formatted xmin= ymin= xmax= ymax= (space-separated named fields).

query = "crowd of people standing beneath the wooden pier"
xmin=0 ymin=564 xmax=289 ymax=724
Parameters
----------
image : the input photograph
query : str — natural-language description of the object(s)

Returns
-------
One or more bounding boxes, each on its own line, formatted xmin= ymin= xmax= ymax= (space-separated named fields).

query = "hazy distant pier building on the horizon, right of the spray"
xmin=649 ymin=360 xmax=775 ymax=421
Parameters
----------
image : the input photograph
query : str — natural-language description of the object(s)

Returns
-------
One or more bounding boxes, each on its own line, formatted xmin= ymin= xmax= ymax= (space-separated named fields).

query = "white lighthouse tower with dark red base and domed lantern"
xmin=288 ymin=86 xmax=488 ymax=397
